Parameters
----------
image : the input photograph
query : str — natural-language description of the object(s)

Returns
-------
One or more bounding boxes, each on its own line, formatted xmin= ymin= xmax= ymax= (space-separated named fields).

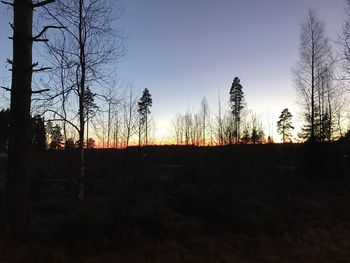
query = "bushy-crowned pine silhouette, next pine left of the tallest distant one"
xmin=137 ymin=88 xmax=152 ymax=145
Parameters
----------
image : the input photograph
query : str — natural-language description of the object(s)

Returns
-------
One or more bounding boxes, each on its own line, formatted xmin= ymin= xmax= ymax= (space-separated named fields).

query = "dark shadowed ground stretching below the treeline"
xmin=0 ymin=144 xmax=350 ymax=263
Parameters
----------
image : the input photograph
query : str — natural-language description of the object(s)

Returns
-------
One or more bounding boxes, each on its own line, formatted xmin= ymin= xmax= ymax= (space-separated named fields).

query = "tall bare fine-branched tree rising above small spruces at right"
xmin=294 ymin=10 xmax=333 ymax=142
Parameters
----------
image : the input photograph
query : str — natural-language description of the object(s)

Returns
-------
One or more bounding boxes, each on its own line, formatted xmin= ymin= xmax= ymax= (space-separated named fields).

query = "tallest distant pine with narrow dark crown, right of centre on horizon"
xmin=230 ymin=77 xmax=244 ymax=143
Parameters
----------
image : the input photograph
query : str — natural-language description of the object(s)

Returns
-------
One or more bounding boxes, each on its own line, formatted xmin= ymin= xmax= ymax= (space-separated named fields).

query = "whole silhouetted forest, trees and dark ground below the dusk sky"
xmin=0 ymin=0 xmax=350 ymax=263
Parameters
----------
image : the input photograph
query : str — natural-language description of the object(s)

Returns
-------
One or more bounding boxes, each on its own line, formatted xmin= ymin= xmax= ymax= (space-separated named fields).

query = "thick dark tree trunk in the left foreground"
xmin=6 ymin=0 xmax=33 ymax=232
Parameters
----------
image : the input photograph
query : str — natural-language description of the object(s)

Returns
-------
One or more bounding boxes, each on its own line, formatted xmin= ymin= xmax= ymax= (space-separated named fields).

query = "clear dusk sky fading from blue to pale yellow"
xmin=0 ymin=0 xmax=345 ymax=141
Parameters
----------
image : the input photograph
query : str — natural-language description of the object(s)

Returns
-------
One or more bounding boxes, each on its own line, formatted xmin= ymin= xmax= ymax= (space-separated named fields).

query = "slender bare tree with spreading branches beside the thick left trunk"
xmin=46 ymin=0 xmax=124 ymax=203
